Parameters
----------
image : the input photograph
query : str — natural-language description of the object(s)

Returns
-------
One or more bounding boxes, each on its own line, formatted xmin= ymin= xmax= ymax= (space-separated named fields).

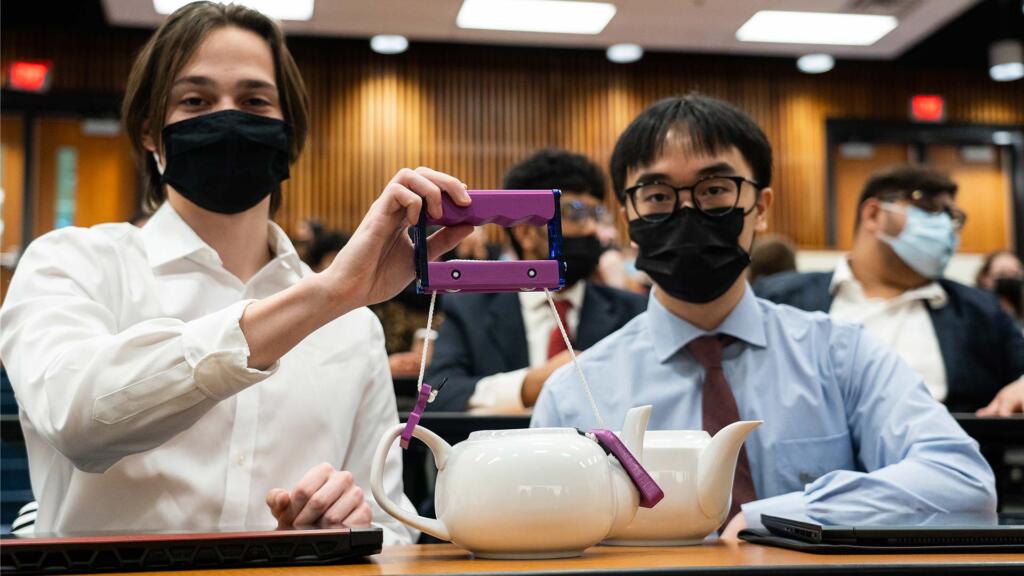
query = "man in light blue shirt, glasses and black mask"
xmin=530 ymin=95 xmax=995 ymax=538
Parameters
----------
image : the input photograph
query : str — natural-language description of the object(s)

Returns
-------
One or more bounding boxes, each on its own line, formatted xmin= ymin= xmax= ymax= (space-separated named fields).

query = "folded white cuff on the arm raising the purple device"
xmin=182 ymin=300 xmax=281 ymax=401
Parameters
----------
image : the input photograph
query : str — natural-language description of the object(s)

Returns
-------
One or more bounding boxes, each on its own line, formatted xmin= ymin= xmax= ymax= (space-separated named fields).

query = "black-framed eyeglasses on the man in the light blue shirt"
xmin=626 ymin=176 xmax=761 ymax=222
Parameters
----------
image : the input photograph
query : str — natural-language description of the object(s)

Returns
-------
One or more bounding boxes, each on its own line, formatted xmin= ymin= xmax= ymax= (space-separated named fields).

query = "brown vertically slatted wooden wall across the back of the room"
xmin=0 ymin=30 xmax=1024 ymax=248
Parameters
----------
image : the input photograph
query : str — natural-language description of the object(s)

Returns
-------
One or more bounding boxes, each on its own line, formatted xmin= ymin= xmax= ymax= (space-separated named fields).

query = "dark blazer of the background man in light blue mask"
xmin=754 ymin=273 xmax=1024 ymax=412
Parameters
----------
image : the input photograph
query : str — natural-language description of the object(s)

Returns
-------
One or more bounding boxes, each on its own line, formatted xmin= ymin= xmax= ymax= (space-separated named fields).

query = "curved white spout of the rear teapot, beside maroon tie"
xmin=697 ymin=420 xmax=762 ymax=519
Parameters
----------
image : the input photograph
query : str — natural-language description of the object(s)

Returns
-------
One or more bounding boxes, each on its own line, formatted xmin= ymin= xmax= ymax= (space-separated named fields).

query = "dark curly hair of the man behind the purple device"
xmin=502 ymin=148 xmax=607 ymax=258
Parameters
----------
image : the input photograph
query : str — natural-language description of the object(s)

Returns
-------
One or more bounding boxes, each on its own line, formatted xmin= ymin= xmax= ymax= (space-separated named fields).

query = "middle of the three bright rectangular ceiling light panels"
xmin=456 ymin=0 xmax=615 ymax=34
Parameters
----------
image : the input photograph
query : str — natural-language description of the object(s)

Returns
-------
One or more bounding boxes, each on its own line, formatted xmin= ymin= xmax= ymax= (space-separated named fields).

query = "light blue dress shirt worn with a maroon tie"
xmin=531 ymin=286 xmax=995 ymax=527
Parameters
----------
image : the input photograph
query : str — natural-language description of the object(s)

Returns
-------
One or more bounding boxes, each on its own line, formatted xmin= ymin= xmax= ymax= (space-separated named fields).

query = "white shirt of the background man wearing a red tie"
xmin=469 ymin=280 xmax=587 ymax=409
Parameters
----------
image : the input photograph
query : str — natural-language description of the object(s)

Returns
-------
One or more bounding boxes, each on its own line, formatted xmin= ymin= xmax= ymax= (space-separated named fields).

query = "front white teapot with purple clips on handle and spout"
xmin=371 ymin=406 xmax=650 ymax=559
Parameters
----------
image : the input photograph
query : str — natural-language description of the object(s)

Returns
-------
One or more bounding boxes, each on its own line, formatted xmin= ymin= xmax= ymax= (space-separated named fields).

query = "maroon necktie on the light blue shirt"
xmin=686 ymin=336 xmax=757 ymax=526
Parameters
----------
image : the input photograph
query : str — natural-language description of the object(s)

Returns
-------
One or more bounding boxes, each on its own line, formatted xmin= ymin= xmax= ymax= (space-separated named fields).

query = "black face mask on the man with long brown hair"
xmin=161 ymin=110 xmax=292 ymax=214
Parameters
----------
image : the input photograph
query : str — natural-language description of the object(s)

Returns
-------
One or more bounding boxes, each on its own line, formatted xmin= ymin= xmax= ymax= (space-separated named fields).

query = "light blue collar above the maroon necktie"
xmin=647 ymin=286 xmax=768 ymax=363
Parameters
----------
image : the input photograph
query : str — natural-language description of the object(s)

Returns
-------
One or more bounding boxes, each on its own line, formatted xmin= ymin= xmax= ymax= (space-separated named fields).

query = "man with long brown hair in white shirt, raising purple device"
xmin=0 ymin=2 xmax=471 ymax=542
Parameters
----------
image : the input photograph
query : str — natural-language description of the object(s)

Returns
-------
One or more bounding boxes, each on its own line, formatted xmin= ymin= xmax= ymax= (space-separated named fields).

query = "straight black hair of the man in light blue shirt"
xmin=610 ymin=93 xmax=772 ymax=203
